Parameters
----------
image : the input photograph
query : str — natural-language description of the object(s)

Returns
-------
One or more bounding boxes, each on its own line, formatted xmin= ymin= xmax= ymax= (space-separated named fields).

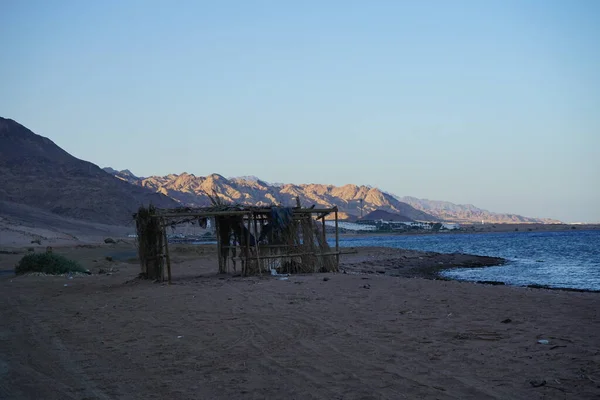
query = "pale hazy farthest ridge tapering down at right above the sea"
xmin=392 ymin=195 xmax=561 ymax=224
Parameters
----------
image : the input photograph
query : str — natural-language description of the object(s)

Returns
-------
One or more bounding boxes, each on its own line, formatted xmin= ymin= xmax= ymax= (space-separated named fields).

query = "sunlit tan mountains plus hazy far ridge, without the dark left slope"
xmin=105 ymin=168 xmax=560 ymax=223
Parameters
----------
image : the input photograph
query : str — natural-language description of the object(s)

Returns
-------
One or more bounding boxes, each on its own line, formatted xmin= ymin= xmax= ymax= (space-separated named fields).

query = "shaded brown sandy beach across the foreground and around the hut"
xmin=0 ymin=243 xmax=600 ymax=400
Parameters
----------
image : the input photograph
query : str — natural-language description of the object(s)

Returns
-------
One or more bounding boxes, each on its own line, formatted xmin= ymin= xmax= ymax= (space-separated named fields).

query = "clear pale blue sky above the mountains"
xmin=0 ymin=0 xmax=600 ymax=221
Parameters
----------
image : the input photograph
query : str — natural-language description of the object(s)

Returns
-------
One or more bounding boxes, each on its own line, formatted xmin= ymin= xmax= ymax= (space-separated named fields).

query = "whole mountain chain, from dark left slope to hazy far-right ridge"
xmin=0 ymin=117 xmax=558 ymax=224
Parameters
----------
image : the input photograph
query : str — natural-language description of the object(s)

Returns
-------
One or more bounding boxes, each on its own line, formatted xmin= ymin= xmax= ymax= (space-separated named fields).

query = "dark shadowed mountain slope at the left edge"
xmin=0 ymin=117 xmax=177 ymax=224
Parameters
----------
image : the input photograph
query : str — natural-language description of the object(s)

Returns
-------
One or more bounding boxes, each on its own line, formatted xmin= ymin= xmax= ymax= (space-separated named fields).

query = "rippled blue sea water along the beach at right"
xmin=340 ymin=231 xmax=600 ymax=290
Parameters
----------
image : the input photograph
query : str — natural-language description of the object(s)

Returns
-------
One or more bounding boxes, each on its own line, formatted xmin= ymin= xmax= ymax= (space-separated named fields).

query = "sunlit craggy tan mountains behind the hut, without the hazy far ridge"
xmin=105 ymin=168 xmax=438 ymax=221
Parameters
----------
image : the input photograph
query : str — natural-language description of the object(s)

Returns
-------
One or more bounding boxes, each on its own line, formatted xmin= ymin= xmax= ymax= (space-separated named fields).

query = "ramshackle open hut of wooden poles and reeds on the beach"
xmin=134 ymin=204 xmax=340 ymax=282
